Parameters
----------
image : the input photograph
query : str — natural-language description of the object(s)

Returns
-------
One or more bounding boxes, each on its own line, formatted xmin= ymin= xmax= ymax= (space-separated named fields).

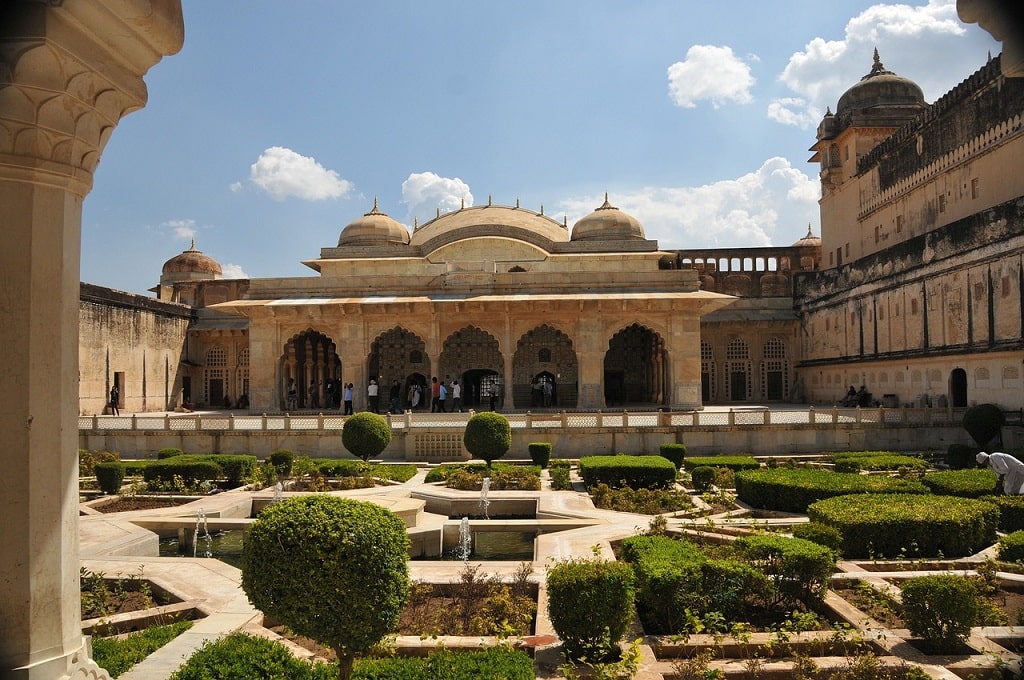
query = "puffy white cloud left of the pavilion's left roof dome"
xmin=244 ymin=146 xmax=352 ymax=201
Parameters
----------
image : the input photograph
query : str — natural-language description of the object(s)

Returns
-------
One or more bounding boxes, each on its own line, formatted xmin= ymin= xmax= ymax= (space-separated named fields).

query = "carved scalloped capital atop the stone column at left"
xmin=0 ymin=0 xmax=184 ymax=197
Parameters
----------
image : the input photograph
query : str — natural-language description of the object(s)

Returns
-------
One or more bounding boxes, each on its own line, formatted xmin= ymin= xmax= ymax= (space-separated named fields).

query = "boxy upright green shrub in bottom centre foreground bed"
xmin=547 ymin=559 xmax=634 ymax=662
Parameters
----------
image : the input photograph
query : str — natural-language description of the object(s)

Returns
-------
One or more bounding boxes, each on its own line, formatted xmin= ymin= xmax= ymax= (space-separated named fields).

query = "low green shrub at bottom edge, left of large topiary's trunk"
xmin=169 ymin=633 xmax=338 ymax=680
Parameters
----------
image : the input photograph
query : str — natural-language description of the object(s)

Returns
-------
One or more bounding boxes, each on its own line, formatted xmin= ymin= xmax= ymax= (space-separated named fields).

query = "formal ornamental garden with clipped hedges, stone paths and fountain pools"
xmin=80 ymin=411 xmax=1024 ymax=680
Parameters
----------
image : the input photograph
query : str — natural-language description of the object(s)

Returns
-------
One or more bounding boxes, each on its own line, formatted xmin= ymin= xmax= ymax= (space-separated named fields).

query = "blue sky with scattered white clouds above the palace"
xmin=82 ymin=0 xmax=1000 ymax=293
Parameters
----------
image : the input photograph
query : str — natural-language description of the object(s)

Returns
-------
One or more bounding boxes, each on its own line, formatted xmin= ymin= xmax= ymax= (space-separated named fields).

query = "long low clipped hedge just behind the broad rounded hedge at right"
xmin=736 ymin=468 xmax=928 ymax=512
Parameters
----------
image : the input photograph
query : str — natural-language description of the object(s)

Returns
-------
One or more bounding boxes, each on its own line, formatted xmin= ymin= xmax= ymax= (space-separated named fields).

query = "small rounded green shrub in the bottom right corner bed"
xmin=901 ymin=573 xmax=982 ymax=653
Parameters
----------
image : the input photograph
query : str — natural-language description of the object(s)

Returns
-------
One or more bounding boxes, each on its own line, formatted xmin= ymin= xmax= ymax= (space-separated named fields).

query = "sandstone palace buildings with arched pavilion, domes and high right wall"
xmin=80 ymin=54 xmax=1024 ymax=415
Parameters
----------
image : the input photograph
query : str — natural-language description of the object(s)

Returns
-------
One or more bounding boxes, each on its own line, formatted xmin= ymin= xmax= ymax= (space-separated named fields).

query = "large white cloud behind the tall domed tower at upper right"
xmin=769 ymin=0 xmax=998 ymax=126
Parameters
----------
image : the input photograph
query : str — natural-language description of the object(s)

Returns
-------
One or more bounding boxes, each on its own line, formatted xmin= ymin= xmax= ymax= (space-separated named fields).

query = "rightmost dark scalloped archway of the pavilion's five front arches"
xmin=604 ymin=324 xmax=668 ymax=407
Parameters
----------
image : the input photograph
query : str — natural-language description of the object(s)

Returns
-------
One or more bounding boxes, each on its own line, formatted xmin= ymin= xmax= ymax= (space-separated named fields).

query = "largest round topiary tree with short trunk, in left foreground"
xmin=242 ymin=495 xmax=410 ymax=680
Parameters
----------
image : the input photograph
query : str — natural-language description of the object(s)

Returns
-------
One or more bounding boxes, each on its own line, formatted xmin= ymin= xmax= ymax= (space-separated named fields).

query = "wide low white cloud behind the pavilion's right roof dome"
xmin=562 ymin=157 xmax=820 ymax=248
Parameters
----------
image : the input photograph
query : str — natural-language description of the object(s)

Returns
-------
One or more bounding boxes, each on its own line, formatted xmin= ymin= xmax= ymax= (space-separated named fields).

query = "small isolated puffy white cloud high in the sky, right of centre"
xmin=669 ymin=45 xmax=755 ymax=109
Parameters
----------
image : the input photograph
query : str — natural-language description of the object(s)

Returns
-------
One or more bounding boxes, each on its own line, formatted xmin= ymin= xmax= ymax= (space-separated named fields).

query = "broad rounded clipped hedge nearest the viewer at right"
xmin=807 ymin=494 xmax=999 ymax=558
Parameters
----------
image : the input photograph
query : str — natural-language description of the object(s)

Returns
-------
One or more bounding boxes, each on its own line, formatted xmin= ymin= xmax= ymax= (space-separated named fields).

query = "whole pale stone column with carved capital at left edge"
xmin=0 ymin=0 xmax=183 ymax=680
